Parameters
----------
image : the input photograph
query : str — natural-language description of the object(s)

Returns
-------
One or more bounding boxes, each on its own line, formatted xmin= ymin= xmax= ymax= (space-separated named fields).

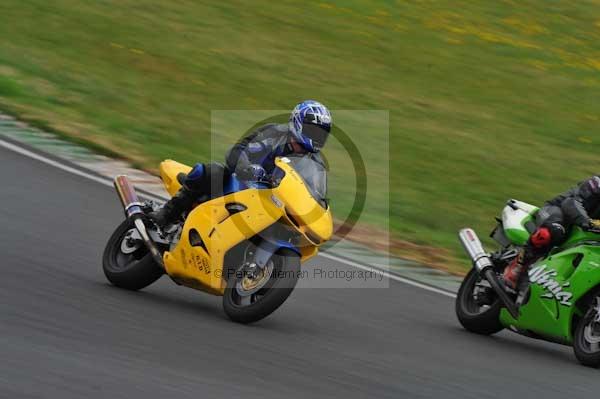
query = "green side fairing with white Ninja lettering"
xmin=500 ymin=228 xmax=600 ymax=344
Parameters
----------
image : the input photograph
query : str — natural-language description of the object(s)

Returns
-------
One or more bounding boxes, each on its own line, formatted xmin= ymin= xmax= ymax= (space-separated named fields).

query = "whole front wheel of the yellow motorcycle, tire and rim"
xmin=223 ymin=249 xmax=300 ymax=324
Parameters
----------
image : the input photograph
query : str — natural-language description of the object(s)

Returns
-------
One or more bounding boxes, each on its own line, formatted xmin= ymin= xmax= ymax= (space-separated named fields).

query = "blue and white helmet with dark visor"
xmin=289 ymin=100 xmax=332 ymax=152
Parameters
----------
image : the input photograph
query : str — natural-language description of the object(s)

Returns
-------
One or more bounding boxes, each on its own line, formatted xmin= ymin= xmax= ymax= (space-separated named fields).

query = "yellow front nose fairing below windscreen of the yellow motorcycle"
xmin=273 ymin=158 xmax=333 ymax=245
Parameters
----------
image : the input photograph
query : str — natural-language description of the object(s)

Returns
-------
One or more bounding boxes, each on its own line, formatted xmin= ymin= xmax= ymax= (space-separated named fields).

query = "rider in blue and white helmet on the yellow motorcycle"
xmin=150 ymin=100 xmax=332 ymax=228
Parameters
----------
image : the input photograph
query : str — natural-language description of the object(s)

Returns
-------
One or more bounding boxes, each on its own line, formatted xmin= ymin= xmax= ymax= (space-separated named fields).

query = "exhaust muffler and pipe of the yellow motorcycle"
xmin=114 ymin=175 xmax=165 ymax=269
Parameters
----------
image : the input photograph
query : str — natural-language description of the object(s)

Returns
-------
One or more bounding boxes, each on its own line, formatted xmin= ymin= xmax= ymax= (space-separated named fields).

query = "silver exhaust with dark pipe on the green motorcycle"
xmin=458 ymin=229 xmax=519 ymax=319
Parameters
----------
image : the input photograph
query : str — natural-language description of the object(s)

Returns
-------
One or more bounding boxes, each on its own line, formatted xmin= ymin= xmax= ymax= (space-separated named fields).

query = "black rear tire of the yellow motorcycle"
xmin=102 ymin=220 xmax=164 ymax=291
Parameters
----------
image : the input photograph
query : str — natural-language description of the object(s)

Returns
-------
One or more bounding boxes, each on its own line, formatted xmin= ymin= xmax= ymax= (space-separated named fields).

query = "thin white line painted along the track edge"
xmin=0 ymin=139 xmax=456 ymax=298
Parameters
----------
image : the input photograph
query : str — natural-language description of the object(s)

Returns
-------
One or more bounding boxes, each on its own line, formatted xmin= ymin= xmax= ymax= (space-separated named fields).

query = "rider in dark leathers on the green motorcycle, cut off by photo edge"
xmin=504 ymin=176 xmax=600 ymax=289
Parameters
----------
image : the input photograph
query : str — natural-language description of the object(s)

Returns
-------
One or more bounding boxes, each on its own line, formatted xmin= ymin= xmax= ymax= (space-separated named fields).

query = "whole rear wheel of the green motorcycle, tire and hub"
xmin=455 ymin=269 xmax=504 ymax=335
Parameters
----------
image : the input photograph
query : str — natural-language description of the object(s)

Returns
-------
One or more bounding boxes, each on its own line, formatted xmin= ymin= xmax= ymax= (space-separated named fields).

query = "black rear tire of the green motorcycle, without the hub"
xmin=455 ymin=269 xmax=504 ymax=335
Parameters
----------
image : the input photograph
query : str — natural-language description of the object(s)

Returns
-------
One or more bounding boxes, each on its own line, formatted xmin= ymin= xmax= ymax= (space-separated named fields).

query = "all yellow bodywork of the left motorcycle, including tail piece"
xmin=160 ymin=158 xmax=333 ymax=295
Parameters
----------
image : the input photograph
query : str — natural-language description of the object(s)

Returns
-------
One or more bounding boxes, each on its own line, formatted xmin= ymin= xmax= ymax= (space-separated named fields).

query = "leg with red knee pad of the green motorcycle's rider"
xmin=504 ymin=206 xmax=567 ymax=289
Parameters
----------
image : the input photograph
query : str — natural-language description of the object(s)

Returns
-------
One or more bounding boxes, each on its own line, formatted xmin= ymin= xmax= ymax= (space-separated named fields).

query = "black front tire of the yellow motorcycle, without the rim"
xmin=223 ymin=249 xmax=300 ymax=324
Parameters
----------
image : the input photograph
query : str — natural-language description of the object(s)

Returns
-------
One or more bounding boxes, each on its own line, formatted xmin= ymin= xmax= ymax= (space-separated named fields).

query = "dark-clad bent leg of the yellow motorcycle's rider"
xmin=151 ymin=163 xmax=226 ymax=227
